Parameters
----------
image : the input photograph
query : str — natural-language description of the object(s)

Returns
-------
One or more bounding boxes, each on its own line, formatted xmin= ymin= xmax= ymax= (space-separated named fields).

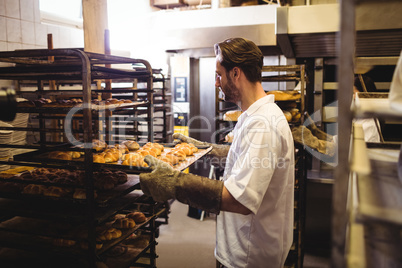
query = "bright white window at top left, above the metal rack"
xmin=39 ymin=0 xmax=83 ymax=29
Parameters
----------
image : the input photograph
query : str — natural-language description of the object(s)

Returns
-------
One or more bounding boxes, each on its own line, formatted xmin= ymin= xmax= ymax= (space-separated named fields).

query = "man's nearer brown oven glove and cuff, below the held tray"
xmin=140 ymin=155 xmax=223 ymax=214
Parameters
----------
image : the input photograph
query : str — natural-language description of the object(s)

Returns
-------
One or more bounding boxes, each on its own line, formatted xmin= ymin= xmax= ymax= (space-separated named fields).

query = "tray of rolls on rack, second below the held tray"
xmin=0 ymin=211 xmax=153 ymax=254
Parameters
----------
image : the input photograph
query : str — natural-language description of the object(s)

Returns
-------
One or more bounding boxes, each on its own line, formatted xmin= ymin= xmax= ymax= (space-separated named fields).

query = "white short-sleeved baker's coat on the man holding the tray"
xmin=215 ymin=95 xmax=295 ymax=268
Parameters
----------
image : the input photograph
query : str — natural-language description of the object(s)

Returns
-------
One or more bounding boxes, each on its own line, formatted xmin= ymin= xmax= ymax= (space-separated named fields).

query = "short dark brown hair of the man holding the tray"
xmin=214 ymin=37 xmax=264 ymax=82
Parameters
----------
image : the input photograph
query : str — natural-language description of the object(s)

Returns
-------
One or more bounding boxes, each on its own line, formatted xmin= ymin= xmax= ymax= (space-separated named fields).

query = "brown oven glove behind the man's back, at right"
xmin=292 ymin=126 xmax=336 ymax=156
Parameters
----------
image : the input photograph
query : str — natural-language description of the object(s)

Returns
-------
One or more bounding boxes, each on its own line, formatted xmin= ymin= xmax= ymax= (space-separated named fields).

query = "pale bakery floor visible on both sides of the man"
xmin=156 ymin=201 xmax=330 ymax=268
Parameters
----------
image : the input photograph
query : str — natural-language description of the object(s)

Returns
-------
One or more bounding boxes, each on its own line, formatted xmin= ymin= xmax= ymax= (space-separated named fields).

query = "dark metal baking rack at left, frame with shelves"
xmin=0 ymin=49 xmax=163 ymax=267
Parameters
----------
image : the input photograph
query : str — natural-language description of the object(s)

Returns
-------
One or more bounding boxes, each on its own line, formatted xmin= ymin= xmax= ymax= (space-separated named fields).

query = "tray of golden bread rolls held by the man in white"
xmin=14 ymin=140 xmax=212 ymax=174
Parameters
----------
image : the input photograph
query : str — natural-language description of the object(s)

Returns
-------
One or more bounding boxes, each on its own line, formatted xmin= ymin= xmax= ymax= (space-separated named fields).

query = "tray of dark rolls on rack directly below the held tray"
xmin=0 ymin=168 xmax=140 ymax=205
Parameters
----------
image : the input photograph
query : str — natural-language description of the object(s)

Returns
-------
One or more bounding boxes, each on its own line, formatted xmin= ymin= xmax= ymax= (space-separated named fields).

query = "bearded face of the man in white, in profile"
xmin=215 ymin=59 xmax=240 ymax=103
